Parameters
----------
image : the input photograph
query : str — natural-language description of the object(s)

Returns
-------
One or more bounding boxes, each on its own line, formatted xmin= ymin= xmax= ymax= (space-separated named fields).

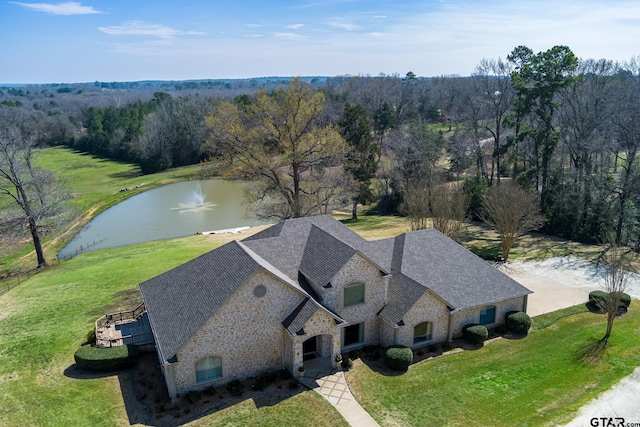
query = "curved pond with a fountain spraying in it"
xmin=58 ymin=179 xmax=264 ymax=259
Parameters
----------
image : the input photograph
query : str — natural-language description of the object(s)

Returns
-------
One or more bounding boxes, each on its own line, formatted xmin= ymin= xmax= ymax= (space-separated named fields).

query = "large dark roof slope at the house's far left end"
xmin=140 ymin=241 xmax=260 ymax=360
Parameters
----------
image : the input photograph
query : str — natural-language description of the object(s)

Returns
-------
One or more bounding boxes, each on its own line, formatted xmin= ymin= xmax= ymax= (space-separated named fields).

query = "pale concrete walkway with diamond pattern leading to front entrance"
xmin=301 ymin=358 xmax=379 ymax=427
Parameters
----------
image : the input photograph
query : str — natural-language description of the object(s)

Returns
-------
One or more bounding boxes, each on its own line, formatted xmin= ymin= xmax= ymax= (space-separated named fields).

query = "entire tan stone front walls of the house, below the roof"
xmin=154 ymin=247 xmax=526 ymax=398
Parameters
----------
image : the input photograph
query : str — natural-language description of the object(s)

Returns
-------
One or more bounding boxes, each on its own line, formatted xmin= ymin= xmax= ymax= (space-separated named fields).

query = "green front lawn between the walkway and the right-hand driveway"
xmin=347 ymin=307 xmax=640 ymax=426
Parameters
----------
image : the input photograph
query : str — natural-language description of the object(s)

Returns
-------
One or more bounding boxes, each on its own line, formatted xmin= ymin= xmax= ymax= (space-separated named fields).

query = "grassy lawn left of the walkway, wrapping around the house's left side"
xmin=0 ymin=234 xmax=344 ymax=426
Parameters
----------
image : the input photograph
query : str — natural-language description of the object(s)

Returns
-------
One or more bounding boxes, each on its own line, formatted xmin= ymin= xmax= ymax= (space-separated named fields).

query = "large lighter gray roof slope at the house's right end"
xmin=392 ymin=229 xmax=531 ymax=311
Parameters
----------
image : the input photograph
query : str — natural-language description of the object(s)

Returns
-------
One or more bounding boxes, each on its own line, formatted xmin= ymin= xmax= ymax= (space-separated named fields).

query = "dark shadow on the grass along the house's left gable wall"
xmin=64 ymin=351 xmax=306 ymax=427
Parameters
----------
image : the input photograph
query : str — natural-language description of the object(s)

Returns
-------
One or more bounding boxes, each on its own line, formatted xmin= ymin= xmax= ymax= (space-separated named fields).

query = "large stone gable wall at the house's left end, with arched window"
xmin=173 ymin=270 xmax=303 ymax=394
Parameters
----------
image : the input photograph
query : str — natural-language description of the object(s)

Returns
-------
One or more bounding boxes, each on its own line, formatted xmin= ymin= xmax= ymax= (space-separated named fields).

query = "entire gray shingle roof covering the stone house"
xmin=140 ymin=215 xmax=531 ymax=360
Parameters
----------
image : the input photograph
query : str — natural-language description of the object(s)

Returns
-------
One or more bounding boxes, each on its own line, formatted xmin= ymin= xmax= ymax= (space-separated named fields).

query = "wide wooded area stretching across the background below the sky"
xmin=0 ymin=46 xmax=640 ymax=249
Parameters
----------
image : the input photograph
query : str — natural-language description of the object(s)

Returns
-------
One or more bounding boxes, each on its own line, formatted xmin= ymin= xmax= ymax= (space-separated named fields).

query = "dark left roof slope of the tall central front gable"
xmin=299 ymin=225 xmax=356 ymax=287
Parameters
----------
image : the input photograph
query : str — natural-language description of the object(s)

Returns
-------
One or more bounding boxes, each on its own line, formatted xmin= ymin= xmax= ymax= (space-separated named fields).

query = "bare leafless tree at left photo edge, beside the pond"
xmin=0 ymin=107 xmax=66 ymax=268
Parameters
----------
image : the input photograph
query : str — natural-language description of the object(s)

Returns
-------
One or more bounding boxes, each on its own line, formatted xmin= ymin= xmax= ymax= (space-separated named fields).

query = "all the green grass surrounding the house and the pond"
xmin=0 ymin=148 xmax=640 ymax=426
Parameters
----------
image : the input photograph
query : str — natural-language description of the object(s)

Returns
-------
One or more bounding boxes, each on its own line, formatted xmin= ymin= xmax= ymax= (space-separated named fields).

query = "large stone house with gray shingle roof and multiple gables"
xmin=140 ymin=216 xmax=531 ymax=398
